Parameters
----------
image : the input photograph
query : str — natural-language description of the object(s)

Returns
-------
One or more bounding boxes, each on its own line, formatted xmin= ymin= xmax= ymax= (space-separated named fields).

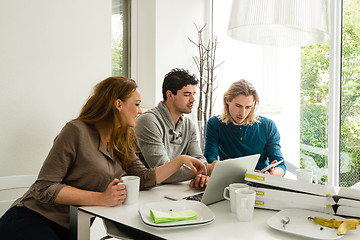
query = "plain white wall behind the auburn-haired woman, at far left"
xmin=0 ymin=0 xmax=111 ymax=176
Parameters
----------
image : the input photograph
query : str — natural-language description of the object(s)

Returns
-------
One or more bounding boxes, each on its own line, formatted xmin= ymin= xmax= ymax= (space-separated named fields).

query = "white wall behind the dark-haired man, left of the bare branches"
xmin=131 ymin=0 xmax=209 ymax=108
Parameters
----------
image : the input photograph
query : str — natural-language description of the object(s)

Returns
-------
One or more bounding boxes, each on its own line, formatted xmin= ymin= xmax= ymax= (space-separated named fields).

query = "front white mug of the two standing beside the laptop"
xmin=235 ymin=189 xmax=256 ymax=222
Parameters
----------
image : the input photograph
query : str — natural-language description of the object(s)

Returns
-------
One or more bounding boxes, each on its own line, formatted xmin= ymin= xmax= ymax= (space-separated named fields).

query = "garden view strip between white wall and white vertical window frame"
xmin=300 ymin=29 xmax=329 ymax=183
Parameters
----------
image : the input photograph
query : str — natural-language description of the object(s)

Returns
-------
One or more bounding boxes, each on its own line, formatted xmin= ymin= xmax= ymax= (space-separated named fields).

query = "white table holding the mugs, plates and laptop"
xmin=71 ymin=183 xmax=360 ymax=240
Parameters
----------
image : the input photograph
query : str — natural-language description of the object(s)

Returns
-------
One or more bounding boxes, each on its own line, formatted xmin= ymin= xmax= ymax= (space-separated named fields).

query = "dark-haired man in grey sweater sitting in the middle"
xmin=135 ymin=68 xmax=215 ymax=187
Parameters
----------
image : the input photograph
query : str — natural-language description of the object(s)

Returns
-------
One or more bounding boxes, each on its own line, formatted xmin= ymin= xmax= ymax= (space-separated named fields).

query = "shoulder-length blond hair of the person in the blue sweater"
xmin=220 ymin=79 xmax=259 ymax=125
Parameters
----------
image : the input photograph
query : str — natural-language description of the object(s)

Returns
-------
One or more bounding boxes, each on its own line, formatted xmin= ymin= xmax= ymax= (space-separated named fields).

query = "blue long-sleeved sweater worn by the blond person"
xmin=204 ymin=116 xmax=286 ymax=173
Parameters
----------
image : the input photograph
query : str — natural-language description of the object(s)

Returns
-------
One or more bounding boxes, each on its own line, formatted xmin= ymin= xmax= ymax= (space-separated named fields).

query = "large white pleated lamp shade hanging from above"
xmin=228 ymin=0 xmax=330 ymax=46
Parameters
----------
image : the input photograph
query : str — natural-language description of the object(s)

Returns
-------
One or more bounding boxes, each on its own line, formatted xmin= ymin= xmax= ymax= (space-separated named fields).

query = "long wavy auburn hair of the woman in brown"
xmin=77 ymin=77 xmax=137 ymax=169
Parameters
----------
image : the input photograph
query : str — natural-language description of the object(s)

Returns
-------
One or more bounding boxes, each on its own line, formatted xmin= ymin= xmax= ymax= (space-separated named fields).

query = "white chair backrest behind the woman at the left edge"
xmin=0 ymin=175 xmax=37 ymax=216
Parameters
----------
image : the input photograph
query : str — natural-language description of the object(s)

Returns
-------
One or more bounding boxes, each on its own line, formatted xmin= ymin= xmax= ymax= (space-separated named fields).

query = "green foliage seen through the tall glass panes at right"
xmin=300 ymin=0 xmax=360 ymax=186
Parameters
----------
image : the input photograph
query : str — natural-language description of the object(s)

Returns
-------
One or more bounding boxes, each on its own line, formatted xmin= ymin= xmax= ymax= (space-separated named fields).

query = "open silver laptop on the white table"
xmin=165 ymin=154 xmax=260 ymax=205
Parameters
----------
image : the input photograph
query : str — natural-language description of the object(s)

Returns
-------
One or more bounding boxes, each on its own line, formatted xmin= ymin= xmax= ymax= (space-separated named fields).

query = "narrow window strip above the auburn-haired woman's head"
xmin=112 ymin=0 xmax=131 ymax=77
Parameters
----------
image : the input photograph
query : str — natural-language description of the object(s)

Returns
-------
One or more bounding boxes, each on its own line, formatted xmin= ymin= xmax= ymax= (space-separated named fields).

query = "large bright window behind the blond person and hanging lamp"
xmin=213 ymin=0 xmax=360 ymax=186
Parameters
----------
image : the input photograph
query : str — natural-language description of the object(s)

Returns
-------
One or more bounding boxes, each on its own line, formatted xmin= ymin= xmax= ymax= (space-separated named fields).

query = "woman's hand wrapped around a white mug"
xmin=103 ymin=178 xmax=126 ymax=207
